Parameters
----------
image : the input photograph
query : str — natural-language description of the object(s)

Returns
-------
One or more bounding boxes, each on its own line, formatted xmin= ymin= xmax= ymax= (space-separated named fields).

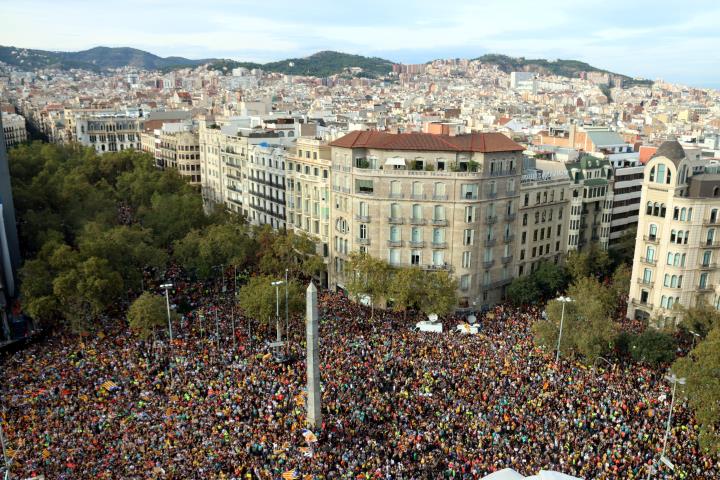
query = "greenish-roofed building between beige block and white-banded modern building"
xmin=565 ymin=155 xmax=614 ymax=251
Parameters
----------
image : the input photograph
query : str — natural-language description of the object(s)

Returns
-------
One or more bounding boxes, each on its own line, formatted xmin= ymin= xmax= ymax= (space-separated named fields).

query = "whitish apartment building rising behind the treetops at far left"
xmin=74 ymin=112 xmax=144 ymax=153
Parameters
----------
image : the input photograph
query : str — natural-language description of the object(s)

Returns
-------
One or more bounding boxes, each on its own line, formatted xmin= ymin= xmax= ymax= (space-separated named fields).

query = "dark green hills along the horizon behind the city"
xmin=0 ymin=46 xmax=651 ymax=83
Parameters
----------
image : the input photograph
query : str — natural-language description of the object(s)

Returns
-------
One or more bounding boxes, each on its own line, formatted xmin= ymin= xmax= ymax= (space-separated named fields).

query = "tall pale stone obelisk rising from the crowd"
xmin=305 ymin=282 xmax=322 ymax=430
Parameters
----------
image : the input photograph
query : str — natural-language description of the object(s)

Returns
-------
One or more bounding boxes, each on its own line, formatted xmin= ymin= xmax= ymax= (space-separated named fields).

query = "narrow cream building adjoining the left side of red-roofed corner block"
xmin=285 ymin=137 xmax=331 ymax=251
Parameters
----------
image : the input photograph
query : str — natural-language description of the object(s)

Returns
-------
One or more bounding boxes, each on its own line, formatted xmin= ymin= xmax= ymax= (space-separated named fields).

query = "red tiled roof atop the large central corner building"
xmin=330 ymin=130 xmax=525 ymax=153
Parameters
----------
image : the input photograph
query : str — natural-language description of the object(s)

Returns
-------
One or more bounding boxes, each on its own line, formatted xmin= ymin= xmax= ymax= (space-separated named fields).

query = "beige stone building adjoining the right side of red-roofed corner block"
xmin=516 ymin=159 xmax=571 ymax=276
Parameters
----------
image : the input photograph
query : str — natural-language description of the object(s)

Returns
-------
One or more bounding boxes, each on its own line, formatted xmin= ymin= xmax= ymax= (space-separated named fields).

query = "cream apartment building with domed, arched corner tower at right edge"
xmin=627 ymin=141 xmax=720 ymax=327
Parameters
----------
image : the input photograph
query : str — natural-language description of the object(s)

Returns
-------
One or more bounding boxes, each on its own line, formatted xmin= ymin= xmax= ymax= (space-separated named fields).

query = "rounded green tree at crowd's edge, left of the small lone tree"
xmin=53 ymin=257 xmax=122 ymax=333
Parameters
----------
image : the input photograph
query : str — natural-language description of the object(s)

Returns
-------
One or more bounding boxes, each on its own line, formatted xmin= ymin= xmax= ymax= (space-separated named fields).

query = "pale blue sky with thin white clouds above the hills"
xmin=0 ymin=0 xmax=720 ymax=86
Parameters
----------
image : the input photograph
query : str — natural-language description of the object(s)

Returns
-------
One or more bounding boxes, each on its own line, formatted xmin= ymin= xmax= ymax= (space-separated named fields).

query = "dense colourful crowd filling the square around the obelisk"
xmin=0 ymin=283 xmax=720 ymax=480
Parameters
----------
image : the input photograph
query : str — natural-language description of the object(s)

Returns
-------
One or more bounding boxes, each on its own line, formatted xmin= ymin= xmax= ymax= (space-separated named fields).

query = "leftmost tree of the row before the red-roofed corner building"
xmin=346 ymin=252 xmax=391 ymax=318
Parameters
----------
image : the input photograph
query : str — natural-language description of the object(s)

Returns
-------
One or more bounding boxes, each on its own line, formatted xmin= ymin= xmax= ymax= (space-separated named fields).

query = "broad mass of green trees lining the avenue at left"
xmin=10 ymin=142 xmax=323 ymax=332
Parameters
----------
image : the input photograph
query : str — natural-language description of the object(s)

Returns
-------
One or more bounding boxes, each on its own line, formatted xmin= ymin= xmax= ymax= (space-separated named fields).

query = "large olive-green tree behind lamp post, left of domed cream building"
xmin=533 ymin=277 xmax=617 ymax=363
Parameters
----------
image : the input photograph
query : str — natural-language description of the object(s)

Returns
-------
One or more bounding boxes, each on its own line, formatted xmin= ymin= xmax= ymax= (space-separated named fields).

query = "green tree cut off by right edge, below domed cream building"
xmin=673 ymin=326 xmax=720 ymax=455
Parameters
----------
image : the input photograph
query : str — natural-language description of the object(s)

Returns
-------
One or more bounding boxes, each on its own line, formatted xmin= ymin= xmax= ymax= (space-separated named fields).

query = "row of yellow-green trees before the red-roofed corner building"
xmin=345 ymin=253 xmax=457 ymax=316
